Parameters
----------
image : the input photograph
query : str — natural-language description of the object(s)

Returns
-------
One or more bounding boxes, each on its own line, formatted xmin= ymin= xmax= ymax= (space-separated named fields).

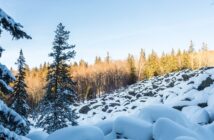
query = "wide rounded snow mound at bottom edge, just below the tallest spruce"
xmin=47 ymin=126 xmax=104 ymax=140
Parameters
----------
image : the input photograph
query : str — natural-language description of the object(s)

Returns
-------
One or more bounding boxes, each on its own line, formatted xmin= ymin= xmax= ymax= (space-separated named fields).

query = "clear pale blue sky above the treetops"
xmin=0 ymin=0 xmax=214 ymax=67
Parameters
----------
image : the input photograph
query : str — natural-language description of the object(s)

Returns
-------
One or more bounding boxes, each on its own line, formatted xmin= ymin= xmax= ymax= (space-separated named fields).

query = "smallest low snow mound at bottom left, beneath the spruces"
xmin=26 ymin=131 xmax=48 ymax=140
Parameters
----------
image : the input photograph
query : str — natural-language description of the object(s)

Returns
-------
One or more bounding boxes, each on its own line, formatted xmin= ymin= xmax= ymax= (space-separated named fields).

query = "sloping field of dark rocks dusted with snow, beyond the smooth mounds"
xmin=74 ymin=68 xmax=214 ymax=124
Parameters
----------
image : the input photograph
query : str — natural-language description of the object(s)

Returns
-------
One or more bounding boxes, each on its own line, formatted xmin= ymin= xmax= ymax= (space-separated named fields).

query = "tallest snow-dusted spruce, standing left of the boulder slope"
xmin=37 ymin=23 xmax=77 ymax=133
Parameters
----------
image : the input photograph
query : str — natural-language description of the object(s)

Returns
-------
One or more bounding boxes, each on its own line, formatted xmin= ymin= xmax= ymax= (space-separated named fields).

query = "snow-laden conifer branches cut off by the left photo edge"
xmin=0 ymin=9 xmax=31 ymax=139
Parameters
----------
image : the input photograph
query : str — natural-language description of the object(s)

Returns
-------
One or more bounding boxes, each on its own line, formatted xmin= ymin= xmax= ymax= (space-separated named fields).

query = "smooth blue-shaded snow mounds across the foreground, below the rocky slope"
xmin=31 ymin=104 xmax=214 ymax=140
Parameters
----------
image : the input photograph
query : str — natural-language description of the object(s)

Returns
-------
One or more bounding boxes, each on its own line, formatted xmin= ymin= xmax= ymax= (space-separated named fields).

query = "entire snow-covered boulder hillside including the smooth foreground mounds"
xmin=27 ymin=68 xmax=214 ymax=140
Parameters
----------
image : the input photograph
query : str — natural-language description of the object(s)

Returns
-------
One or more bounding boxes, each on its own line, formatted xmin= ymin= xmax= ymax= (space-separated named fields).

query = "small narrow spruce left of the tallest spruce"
xmin=11 ymin=50 xmax=30 ymax=118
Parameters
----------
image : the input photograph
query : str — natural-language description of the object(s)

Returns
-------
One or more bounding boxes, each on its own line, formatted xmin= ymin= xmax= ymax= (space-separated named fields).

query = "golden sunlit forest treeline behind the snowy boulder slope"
xmin=21 ymin=41 xmax=214 ymax=107
